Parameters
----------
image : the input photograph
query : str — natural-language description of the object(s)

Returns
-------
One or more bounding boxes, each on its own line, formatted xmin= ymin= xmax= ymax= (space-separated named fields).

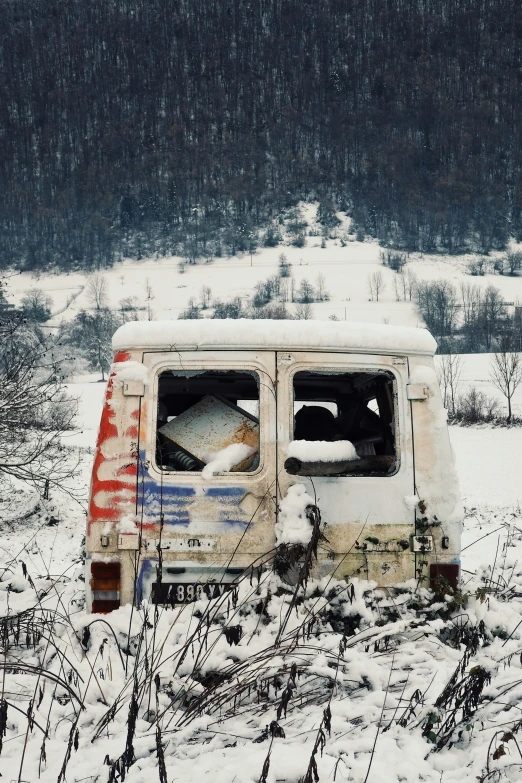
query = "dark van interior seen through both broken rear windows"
xmin=156 ymin=370 xmax=396 ymax=476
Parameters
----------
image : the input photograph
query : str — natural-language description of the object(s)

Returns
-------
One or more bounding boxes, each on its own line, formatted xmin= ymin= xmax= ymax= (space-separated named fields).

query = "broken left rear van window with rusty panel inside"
xmin=156 ymin=370 xmax=260 ymax=476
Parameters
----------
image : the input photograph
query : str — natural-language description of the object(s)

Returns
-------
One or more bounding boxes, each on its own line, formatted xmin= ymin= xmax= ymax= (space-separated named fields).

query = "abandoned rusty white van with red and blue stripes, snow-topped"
xmin=87 ymin=320 xmax=462 ymax=612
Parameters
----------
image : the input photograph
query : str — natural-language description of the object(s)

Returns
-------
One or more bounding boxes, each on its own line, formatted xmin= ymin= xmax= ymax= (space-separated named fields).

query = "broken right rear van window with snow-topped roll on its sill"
xmin=285 ymin=371 xmax=397 ymax=476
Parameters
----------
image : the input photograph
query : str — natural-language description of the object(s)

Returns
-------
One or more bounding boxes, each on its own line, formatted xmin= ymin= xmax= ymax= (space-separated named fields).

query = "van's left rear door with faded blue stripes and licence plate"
xmin=136 ymin=350 xmax=276 ymax=603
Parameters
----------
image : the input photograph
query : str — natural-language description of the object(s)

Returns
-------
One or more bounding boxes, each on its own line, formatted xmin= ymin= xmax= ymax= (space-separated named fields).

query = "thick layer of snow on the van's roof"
xmin=112 ymin=318 xmax=437 ymax=356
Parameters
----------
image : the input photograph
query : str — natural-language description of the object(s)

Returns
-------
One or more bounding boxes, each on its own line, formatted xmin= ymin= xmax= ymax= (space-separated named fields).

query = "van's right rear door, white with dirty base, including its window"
xmin=277 ymin=352 xmax=415 ymax=583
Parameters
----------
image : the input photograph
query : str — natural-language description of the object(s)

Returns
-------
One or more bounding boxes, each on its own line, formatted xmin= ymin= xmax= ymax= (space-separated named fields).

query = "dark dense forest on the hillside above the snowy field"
xmin=0 ymin=0 xmax=522 ymax=269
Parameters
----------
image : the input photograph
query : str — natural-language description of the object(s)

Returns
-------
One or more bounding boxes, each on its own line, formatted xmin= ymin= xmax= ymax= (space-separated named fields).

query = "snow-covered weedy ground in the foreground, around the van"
xmin=0 ymin=376 xmax=522 ymax=783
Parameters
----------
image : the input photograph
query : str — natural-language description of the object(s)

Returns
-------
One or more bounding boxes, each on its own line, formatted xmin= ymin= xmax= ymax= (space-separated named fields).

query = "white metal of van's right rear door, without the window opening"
xmin=277 ymin=351 xmax=415 ymax=582
